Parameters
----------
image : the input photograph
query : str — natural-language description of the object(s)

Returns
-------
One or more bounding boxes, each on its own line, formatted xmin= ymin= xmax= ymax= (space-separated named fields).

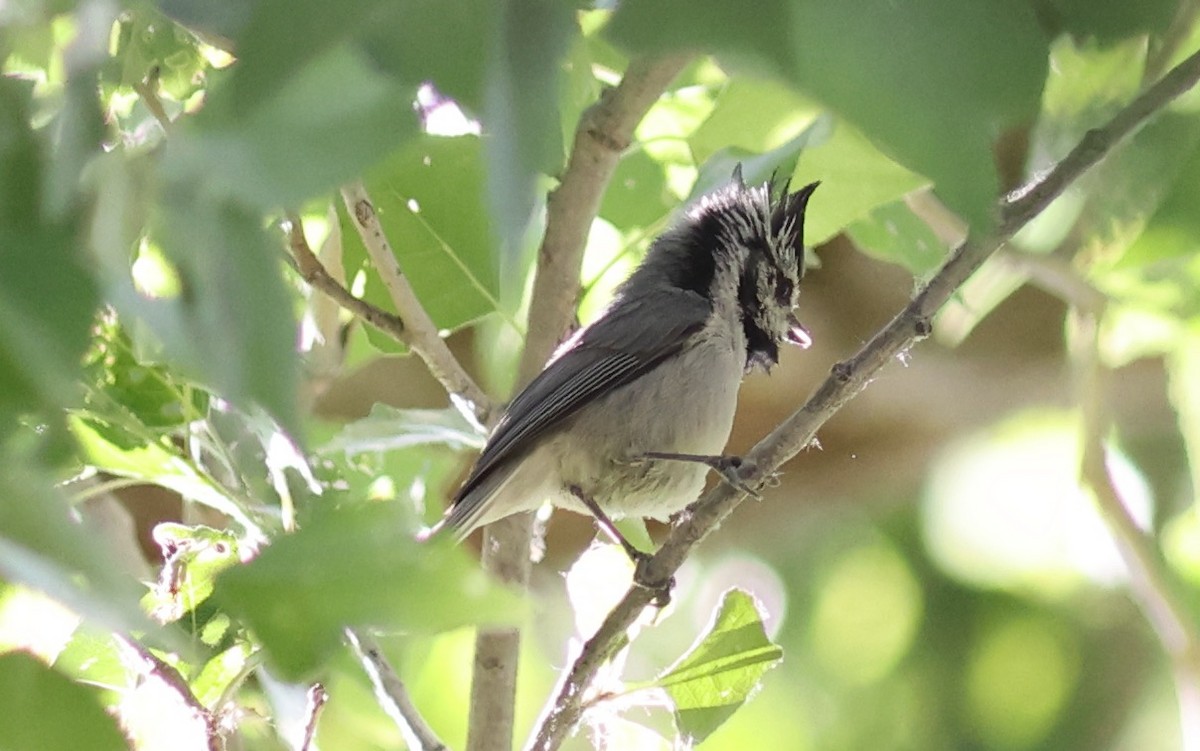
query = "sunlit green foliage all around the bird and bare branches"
xmin=0 ymin=0 xmax=1200 ymax=751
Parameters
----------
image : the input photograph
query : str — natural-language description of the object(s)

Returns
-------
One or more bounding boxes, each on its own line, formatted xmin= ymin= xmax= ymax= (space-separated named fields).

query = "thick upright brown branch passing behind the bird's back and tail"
xmin=467 ymin=55 xmax=688 ymax=751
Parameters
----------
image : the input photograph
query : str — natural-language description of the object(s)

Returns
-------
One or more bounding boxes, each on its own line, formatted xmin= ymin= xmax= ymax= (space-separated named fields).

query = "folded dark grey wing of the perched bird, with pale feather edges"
xmin=446 ymin=290 xmax=710 ymax=527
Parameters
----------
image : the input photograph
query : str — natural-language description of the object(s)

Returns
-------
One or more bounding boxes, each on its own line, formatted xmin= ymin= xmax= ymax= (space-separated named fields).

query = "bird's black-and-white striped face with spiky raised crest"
xmin=694 ymin=173 xmax=817 ymax=371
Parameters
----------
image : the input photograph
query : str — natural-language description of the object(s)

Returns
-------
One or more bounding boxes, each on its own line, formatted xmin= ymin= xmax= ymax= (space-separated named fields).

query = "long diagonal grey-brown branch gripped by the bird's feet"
xmin=530 ymin=42 xmax=1200 ymax=751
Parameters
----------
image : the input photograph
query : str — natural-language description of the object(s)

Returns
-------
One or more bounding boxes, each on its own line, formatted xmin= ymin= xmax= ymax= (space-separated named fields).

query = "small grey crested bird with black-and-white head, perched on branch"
xmin=437 ymin=164 xmax=818 ymax=555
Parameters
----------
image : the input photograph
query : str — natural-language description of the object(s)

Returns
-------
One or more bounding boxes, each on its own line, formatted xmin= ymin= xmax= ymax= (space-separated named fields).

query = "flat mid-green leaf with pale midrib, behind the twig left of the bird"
xmin=338 ymin=136 xmax=499 ymax=352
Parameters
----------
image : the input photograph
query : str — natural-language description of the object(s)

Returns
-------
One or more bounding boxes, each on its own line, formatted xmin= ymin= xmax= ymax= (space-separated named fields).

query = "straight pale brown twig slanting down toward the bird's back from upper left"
xmin=342 ymin=180 xmax=492 ymax=425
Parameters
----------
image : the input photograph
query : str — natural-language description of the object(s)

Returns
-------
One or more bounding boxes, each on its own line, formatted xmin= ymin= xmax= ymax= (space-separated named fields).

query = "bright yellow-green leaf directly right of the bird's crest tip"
xmin=792 ymin=122 xmax=929 ymax=245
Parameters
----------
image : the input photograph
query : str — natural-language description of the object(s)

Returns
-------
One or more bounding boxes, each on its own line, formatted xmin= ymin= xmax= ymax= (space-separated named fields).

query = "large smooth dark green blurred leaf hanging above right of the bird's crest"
xmin=791 ymin=0 xmax=1048 ymax=228
